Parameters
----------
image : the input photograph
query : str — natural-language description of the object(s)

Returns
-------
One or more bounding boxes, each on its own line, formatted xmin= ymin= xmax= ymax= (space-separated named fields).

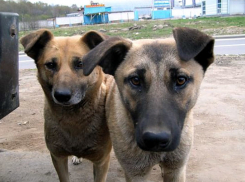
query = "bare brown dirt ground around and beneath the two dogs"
xmin=0 ymin=56 xmax=245 ymax=182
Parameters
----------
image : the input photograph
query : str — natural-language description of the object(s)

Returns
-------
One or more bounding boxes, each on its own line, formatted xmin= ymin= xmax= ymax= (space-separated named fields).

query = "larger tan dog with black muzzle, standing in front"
xmin=83 ymin=28 xmax=214 ymax=182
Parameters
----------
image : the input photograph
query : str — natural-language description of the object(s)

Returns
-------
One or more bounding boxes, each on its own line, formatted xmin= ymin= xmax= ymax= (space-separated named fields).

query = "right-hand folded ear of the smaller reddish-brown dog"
xmin=81 ymin=30 xmax=109 ymax=49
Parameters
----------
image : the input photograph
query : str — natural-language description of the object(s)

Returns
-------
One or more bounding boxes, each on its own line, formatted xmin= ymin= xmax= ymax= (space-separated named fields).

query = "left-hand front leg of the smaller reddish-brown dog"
xmin=51 ymin=154 xmax=70 ymax=182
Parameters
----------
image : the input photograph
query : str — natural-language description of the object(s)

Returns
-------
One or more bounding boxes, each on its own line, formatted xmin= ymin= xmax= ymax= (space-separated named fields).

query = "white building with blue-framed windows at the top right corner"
xmin=201 ymin=0 xmax=245 ymax=16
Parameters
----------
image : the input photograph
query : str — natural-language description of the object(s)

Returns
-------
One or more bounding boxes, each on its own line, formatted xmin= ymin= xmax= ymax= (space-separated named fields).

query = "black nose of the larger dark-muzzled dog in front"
xmin=142 ymin=132 xmax=171 ymax=149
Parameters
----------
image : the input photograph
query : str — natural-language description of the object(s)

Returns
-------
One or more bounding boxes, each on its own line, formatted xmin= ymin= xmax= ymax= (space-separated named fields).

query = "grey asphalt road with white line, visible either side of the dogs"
xmin=19 ymin=37 xmax=245 ymax=69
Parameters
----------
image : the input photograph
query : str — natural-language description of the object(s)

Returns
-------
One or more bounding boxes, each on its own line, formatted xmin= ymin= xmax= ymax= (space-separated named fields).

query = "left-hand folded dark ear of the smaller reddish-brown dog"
xmin=20 ymin=29 xmax=54 ymax=62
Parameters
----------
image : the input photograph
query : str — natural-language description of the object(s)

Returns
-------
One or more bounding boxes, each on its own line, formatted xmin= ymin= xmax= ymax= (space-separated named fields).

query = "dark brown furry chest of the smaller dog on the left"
xmin=45 ymin=104 xmax=109 ymax=158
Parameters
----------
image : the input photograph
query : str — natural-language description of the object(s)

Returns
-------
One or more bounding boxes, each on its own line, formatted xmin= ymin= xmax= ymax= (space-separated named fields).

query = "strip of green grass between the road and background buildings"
xmin=19 ymin=16 xmax=245 ymax=51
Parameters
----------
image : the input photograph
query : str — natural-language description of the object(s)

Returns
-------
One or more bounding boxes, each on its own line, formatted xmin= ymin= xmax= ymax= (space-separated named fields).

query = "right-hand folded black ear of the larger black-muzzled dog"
xmin=173 ymin=27 xmax=214 ymax=71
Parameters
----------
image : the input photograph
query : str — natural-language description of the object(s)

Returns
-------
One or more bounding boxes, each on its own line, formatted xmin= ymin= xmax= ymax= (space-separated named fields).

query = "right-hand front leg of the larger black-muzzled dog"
xmin=163 ymin=165 xmax=186 ymax=182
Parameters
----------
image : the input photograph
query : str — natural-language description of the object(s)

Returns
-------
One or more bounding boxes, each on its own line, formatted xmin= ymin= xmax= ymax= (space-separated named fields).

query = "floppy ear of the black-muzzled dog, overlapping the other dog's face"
xmin=83 ymin=37 xmax=132 ymax=75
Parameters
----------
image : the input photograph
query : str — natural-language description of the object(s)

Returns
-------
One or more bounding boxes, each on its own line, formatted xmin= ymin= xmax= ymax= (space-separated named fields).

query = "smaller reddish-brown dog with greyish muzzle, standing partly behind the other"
xmin=21 ymin=30 xmax=112 ymax=182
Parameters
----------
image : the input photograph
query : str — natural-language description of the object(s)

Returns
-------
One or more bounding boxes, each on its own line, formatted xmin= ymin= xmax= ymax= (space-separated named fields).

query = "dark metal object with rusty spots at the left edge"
xmin=0 ymin=12 xmax=19 ymax=119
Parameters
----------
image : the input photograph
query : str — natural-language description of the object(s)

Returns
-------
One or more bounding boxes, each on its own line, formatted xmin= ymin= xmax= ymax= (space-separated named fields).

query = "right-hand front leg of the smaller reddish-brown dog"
xmin=93 ymin=154 xmax=110 ymax=182
